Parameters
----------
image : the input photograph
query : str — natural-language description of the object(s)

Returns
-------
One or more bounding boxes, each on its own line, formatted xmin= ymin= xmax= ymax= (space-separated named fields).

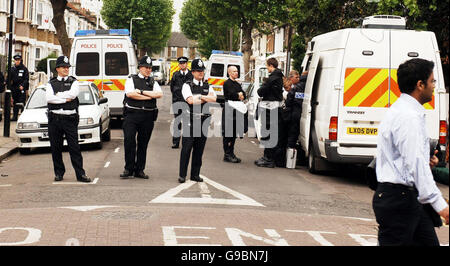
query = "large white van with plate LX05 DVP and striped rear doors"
xmin=299 ymin=16 xmax=448 ymax=173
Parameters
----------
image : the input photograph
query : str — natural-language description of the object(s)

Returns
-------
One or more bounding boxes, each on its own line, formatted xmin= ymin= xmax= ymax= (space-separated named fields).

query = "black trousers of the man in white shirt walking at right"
xmin=372 ymin=183 xmax=439 ymax=246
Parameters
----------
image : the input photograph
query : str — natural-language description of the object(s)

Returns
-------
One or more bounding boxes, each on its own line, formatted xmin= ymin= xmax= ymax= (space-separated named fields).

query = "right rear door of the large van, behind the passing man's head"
xmin=390 ymin=30 xmax=444 ymax=139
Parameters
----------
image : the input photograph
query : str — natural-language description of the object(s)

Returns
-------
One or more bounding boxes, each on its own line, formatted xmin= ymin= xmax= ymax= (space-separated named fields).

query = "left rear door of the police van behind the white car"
xmin=71 ymin=38 xmax=102 ymax=85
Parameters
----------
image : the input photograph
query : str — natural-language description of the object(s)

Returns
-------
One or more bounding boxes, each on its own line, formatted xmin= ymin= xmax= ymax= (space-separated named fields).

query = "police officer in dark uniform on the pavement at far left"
xmin=11 ymin=55 xmax=29 ymax=121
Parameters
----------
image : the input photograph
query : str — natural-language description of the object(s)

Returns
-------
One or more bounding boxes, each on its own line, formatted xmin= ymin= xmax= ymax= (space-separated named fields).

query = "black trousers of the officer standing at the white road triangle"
xmin=180 ymin=118 xmax=210 ymax=178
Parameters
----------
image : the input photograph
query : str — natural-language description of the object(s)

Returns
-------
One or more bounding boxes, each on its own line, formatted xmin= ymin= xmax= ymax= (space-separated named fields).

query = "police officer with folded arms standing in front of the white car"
xmin=46 ymin=56 xmax=91 ymax=183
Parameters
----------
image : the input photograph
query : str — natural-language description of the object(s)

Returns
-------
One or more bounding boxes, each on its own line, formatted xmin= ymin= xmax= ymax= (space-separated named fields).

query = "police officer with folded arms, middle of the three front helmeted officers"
xmin=120 ymin=56 xmax=163 ymax=179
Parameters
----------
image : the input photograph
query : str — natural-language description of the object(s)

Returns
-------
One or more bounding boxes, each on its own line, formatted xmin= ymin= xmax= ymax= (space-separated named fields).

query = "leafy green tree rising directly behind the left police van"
xmin=101 ymin=0 xmax=175 ymax=55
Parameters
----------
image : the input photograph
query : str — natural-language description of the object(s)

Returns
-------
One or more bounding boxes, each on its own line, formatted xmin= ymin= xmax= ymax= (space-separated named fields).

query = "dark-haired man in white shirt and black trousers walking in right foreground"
xmin=373 ymin=59 xmax=449 ymax=246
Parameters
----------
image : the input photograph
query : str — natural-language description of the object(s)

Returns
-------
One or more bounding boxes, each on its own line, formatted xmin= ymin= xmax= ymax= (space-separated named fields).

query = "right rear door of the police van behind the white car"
xmin=101 ymin=38 xmax=129 ymax=107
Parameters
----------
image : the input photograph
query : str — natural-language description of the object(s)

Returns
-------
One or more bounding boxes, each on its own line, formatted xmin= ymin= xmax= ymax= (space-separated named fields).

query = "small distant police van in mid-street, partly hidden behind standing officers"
xmin=205 ymin=50 xmax=244 ymax=101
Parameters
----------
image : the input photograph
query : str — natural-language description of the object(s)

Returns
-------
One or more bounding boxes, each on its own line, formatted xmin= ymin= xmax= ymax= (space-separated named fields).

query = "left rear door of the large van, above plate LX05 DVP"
xmin=337 ymin=29 xmax=393 ymax=156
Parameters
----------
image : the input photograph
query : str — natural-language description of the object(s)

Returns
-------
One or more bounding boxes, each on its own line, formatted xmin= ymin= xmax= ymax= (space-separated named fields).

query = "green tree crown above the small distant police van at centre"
xmin=180 ymin=0 xmax=239 ymax=57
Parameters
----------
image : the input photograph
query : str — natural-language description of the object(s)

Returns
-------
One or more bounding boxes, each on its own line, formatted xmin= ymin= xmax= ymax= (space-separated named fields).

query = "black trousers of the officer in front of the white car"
xmin=48 ymin=113 xmax=85 ymax=179
